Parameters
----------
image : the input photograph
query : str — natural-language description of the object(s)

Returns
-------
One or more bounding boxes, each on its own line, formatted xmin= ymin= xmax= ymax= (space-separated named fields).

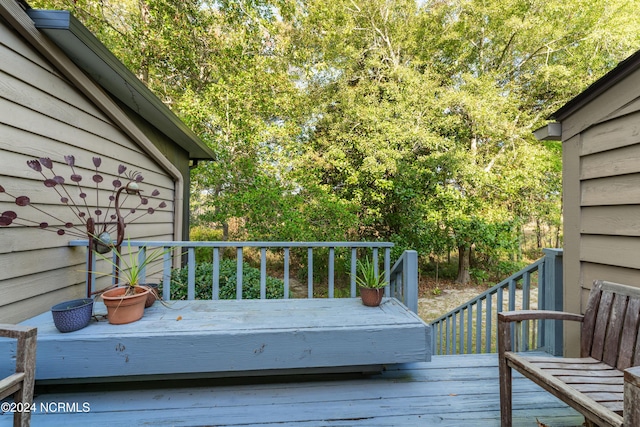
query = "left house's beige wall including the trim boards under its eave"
xmin=0 ymin=0 xmax=208 ymax=323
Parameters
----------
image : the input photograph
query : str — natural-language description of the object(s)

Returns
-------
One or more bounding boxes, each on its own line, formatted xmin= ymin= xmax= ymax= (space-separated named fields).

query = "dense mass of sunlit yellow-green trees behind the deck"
xmin=34 ymin=0 xmax=640 ymax=283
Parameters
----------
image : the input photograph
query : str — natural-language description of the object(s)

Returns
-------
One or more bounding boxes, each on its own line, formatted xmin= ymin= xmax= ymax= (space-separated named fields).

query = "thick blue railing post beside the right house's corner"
xmin=538 ymin=249 xmax=564 ymax=356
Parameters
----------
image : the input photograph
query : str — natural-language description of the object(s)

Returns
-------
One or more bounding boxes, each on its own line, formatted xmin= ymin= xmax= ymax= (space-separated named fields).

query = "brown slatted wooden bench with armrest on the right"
xmin=498 ymin=281 xmax=640 ymax=427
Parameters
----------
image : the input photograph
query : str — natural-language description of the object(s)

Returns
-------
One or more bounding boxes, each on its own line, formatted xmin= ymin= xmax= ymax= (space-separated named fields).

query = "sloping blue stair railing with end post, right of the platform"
xmin=431 ymin=249 xmax=562 ymax=355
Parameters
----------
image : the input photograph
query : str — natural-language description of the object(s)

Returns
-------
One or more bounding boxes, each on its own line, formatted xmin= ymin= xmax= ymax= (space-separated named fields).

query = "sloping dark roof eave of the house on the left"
xmin=27 ymin=9 xmax=215 ymax=161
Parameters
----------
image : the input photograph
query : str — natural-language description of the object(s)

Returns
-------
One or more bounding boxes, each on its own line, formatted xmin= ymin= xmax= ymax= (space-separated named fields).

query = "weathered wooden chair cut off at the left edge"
xmin=0 ymin=324 xmax=38 ymax=427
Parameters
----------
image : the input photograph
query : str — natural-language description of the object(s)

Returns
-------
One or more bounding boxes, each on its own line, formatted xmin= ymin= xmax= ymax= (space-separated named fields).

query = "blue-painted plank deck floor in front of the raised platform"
xmin=0 ymin=354 xmax=584 ymax=427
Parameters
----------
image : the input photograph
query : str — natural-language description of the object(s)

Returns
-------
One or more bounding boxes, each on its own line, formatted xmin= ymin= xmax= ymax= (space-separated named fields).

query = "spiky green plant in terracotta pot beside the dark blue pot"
xmin=94 ymin=241 xmax=167 ymax=325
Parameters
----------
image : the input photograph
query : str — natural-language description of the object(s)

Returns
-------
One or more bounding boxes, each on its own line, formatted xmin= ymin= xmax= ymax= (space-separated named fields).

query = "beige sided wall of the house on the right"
xmin=554 ymin=54 xmax=640 ymax=355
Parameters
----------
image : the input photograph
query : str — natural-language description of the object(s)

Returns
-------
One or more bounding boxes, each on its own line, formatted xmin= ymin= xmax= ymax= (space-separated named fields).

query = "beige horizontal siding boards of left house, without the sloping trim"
xmin=0 ymin=18 xmax=175 ymax=323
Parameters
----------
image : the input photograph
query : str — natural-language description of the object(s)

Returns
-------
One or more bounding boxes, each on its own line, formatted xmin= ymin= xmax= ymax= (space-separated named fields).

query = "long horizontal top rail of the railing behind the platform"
xmin=69 ymin=240 xmax=394 ymax=248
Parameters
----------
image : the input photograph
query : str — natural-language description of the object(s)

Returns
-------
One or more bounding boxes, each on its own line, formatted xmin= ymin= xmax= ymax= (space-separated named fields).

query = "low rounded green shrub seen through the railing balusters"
xmin=171 ymin=259 xmax=284 ymax=300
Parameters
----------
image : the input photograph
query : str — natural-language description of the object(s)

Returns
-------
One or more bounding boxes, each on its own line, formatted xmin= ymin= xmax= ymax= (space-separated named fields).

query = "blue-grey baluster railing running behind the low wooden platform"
xmin=70 ymin=240 xmax=418 ymax=313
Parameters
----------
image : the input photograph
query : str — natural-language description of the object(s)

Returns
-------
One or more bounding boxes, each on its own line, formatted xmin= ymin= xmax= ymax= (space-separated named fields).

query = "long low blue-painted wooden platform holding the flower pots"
xmin=0 ymin=298 xmax=431 ymax=384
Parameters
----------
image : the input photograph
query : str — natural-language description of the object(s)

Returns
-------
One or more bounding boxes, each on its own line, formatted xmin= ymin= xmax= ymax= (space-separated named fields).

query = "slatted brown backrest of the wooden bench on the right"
xmin=580 ymin=280 xmax=640 ymax=370
